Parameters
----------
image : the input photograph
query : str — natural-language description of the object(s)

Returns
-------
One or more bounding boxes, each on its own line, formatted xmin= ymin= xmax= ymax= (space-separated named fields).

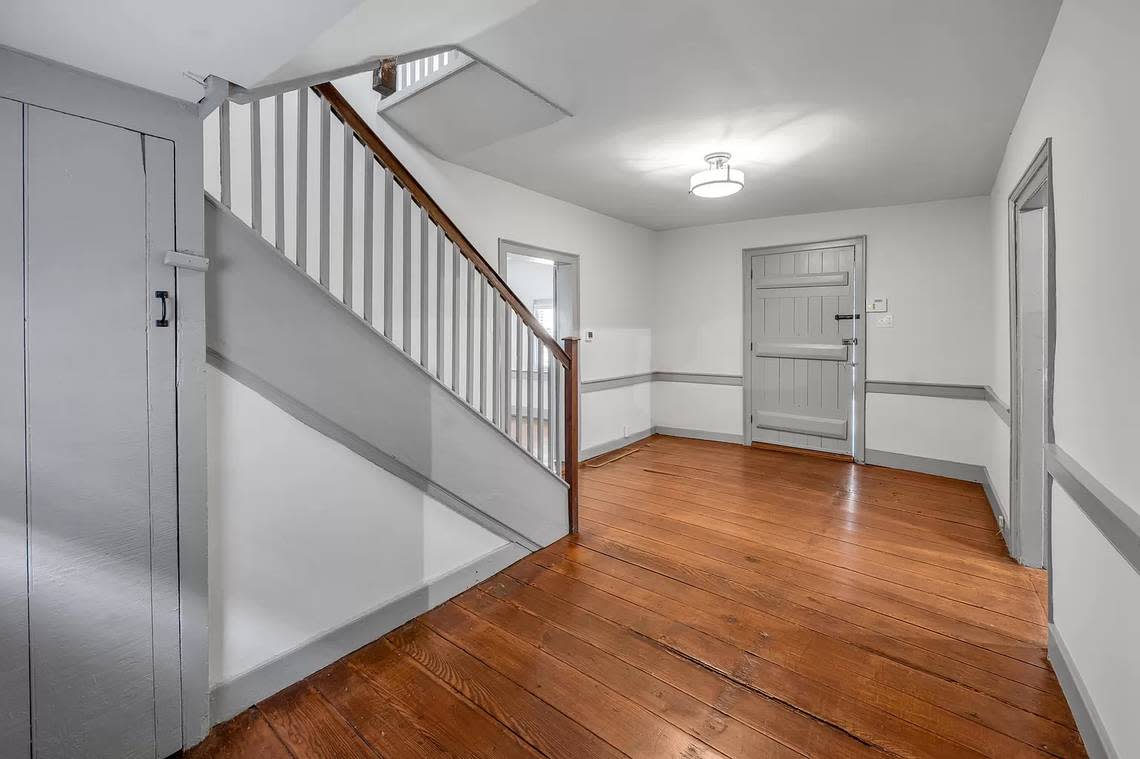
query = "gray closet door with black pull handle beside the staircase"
xmin=25 ymin=106 xmax=180 ymax=759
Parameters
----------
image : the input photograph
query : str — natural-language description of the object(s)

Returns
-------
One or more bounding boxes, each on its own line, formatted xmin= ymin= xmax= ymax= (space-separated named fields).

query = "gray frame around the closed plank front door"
xmin=740 ymin=235 xmax=866 ymax=464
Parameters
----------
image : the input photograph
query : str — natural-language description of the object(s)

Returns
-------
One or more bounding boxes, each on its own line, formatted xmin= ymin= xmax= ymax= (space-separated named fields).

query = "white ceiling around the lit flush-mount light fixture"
xmin=442 ymin=0 xmax=1060 ymax=229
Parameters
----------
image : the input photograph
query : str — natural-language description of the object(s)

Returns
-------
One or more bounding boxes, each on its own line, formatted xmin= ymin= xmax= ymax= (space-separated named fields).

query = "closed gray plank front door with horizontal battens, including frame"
xmin=744 ymin=238 xmax=863 ymax=459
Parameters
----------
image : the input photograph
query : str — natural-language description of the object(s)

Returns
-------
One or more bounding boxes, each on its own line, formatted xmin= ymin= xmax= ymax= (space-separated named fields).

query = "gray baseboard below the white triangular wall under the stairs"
xmin=210 ymin=545 xmax=529 ymax=724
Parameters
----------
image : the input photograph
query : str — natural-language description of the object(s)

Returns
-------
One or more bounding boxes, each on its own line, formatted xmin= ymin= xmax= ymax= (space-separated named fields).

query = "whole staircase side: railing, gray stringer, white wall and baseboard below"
xmin=205 ymin=81 xmax=577 ymax=721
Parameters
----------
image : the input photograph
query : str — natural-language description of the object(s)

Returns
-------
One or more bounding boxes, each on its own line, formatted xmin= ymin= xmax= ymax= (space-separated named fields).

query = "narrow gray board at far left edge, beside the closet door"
xmin=0 ymin=98 xmax=31 ymax=759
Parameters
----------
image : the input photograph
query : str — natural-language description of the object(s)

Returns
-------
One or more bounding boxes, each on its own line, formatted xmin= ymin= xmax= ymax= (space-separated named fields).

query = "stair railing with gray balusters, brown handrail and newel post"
xmin=204 ymin=78 xmax=579 ymax=532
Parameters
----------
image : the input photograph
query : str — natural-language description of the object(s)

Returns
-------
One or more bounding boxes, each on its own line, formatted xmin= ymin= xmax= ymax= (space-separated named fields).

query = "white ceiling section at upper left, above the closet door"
xmin=0 ymin=0 xmax=535 ymax=101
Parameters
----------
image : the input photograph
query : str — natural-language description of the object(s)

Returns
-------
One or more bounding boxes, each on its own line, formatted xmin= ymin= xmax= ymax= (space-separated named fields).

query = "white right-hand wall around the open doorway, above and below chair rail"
xmin=990 ymin=0 xmax=1140 ymax=757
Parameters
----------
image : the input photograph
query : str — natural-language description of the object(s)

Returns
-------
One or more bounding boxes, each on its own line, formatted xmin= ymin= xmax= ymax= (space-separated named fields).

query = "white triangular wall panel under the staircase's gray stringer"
xmin=206 ymin=367 xmax=506 ymax=687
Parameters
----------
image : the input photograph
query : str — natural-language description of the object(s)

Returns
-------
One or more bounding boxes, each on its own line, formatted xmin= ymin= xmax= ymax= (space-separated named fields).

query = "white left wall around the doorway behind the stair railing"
xmin=335 ymin=74 xmax=656 ymax=448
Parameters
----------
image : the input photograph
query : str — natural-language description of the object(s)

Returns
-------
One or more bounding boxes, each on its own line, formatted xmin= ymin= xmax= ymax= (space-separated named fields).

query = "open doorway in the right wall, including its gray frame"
xmin=1009 ymin=140 xmax=1057 ymax=568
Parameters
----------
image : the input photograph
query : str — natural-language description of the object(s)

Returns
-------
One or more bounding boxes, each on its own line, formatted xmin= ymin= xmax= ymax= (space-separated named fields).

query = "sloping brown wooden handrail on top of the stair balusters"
xmin=312 ymin=82 xmax=577 ymax=366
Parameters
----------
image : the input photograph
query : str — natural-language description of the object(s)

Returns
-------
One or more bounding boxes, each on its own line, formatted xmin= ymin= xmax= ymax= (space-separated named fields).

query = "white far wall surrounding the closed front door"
xmin=653 ymin=197 xmax=993 ymax=463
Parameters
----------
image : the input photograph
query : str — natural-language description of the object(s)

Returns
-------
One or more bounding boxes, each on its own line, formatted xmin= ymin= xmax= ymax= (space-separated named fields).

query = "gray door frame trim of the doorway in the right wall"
xmin=1007 ymin=138 xmax=1057 ymax=569
